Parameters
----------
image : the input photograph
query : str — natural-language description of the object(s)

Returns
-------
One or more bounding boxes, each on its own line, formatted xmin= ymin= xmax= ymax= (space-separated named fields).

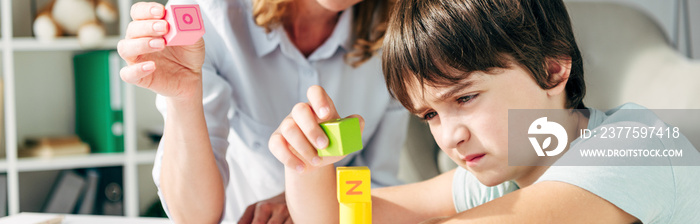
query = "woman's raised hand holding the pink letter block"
xmin=117 ymin=2 xmax=204 ymax=98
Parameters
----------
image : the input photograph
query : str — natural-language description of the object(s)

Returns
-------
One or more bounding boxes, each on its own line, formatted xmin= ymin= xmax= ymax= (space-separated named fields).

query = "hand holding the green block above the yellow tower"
xmin=268 ymin=86 xmax=365 ymax=173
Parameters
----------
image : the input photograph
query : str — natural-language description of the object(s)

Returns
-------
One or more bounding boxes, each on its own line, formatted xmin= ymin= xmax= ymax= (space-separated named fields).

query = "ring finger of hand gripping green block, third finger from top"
xmin=280 ymin=117 xmax=321 ymax=165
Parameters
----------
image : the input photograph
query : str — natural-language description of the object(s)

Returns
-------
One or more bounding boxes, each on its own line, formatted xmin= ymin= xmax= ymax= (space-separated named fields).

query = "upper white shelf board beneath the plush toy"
xmin=0 ymin=36 xmax=121 ymax=51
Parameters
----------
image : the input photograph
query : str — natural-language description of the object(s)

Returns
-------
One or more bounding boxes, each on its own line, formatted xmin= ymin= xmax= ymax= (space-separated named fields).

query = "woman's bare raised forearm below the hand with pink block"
xmin=160 ymin=93 xmax=225 ymax=223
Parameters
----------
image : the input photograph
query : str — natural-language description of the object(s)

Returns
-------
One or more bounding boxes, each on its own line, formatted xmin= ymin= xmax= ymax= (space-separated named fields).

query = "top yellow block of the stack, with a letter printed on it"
xmin=335 ymin=166 xmax=372 ymax=203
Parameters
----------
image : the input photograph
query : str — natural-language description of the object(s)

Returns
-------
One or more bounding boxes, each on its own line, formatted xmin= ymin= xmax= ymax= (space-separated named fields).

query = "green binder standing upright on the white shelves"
xmin=73 ymin=50 xmax=124 ymax=153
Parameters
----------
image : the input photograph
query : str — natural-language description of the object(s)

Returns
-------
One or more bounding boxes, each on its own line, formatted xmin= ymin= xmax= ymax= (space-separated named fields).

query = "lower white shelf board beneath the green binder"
xmin=0 ymin=150 xmax=156 ymax=172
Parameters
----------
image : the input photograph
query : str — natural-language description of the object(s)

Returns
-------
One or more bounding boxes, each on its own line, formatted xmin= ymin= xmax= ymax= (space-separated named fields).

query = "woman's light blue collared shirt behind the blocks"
xmin=153 ymin=0 xmax=409 ymax=222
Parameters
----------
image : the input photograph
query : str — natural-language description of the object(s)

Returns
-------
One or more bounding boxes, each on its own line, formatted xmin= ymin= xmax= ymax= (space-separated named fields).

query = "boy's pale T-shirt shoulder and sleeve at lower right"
xmin=536 ymin=103 xmax=700 ymax=223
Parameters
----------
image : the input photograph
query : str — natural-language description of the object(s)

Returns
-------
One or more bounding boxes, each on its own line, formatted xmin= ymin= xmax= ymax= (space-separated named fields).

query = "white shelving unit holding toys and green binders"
xmin=0 ymin=0 xmax=163 ymax=217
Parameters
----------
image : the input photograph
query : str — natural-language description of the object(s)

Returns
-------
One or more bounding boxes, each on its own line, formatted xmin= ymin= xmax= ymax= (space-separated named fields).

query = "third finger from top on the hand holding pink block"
xmin=117 ymin=37 xmax=165 ymax=63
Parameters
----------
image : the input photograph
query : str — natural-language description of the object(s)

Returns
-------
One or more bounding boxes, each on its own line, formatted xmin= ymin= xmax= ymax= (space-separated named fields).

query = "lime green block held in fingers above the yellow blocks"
xmin=318 ymin=118 xmax=362 ymax=156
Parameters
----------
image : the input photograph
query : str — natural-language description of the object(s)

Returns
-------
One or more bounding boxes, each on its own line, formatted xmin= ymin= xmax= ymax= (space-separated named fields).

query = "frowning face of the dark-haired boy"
xmin=409 ymin=64 xmax=557 ymax=186
